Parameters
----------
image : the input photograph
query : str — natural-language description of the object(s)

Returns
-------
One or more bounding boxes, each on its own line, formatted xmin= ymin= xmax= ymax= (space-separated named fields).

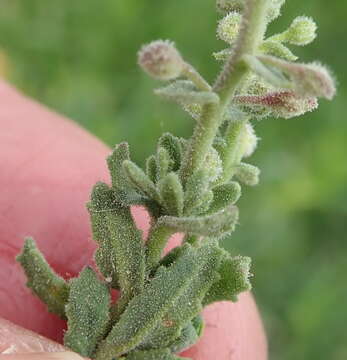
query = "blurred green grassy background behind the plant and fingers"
xmin=0 ymin=0 xmax=347 ymax=360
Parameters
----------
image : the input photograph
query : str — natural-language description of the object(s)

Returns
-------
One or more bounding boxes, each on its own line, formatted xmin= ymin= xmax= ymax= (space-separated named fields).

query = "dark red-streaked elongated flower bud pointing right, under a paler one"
xmin=235 ymin=91 xmax=318 ymax=119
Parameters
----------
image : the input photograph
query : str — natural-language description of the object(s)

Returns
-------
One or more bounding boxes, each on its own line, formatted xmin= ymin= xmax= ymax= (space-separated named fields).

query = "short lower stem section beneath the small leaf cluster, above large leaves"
xmin=146 ymin=224 xmax=174 ymax=271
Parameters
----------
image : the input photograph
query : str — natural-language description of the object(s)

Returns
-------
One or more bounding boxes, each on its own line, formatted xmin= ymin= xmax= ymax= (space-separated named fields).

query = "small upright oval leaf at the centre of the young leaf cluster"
xmin=158 ymin=172 xmax=184 ymax=216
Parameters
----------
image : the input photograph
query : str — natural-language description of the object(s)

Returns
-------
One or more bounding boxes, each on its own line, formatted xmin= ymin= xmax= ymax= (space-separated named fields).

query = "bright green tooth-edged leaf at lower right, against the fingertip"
xmin=203 ymin=251 xmax=252 ymax=306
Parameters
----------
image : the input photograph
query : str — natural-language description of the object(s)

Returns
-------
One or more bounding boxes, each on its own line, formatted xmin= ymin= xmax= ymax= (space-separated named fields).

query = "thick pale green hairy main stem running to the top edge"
xmin=180 ymin=0 xmax=269 ymax=184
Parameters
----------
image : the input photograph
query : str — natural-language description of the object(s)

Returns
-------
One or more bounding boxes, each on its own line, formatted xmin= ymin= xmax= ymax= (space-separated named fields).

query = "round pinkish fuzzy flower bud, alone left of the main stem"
xmin=138 ymin=40 xmax=185 ymax=80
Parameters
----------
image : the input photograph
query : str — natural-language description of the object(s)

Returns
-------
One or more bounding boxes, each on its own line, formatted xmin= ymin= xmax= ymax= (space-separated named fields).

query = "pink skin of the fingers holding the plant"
xmin=0 ymin=82 xmax=267 ymax=360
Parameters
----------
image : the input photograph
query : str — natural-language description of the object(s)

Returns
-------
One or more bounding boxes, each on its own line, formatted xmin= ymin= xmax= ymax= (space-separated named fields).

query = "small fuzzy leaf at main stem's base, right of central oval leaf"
xmin=184 ymin=168 xmax=210 ymax=214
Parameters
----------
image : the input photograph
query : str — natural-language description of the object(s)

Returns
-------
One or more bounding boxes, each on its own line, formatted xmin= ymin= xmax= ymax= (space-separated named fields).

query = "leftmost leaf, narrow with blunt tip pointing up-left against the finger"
xmin=17 ymin=238 xmax=70 ymax=319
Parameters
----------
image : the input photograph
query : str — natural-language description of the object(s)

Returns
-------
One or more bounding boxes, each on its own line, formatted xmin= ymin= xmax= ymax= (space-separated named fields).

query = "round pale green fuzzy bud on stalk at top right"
xmin=282 ymin=16 xmax=317 ymax=46
